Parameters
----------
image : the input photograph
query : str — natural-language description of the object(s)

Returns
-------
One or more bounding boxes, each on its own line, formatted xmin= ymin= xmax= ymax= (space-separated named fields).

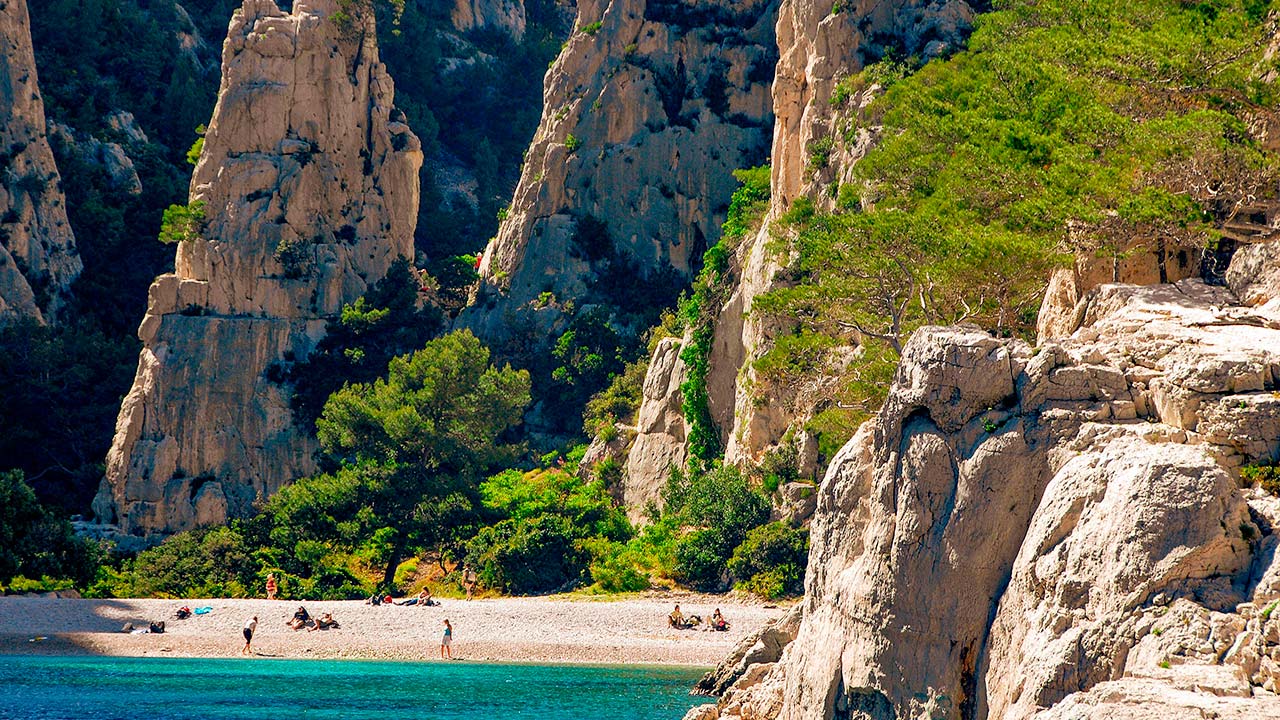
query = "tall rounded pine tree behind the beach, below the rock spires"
xmin=316 ymin=331 xmax=529 ymax=584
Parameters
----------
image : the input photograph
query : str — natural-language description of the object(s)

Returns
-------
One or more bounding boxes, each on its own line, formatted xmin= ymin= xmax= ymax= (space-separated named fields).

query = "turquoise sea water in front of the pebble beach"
xmin=0 ymin=656 xmax=707 ymax=720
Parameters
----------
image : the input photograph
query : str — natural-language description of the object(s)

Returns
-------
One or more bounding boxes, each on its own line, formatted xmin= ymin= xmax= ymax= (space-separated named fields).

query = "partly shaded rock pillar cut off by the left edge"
xmin=0 ymin=0 xmax=83 ymax=322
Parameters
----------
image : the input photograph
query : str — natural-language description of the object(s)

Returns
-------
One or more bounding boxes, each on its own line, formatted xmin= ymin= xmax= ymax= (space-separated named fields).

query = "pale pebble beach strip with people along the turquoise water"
xmin=0 ymin=593 xmax=785 ymax=666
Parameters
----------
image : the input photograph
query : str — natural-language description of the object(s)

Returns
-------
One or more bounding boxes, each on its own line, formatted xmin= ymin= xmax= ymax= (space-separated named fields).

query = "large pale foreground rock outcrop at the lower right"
xmin=698 ymin=242 xmax=1280 ymax=720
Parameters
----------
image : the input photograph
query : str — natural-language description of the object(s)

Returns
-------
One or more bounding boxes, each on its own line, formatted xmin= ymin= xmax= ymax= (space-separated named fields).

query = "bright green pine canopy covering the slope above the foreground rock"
xmin=753 ymin=0 xmax=1280 ymax=430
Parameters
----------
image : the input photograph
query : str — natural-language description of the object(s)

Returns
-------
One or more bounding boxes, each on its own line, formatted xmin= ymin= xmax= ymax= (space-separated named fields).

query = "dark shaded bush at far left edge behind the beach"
xmin=0 ymin=470 xmax=97 ymax=587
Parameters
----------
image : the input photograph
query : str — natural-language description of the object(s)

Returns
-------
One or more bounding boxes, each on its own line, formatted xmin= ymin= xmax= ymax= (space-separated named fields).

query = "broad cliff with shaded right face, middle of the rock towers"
xmin=462 ymin=0 xmax=777 ymax=342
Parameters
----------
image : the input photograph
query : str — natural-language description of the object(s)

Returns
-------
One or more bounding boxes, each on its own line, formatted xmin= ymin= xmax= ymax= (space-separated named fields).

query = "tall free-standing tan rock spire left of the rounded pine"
xmin=95 ymin=0 xmax=422 ymax=536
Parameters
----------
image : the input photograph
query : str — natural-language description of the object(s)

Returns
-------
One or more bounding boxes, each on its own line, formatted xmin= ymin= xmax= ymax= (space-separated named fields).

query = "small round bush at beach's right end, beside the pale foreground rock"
xmin=728 ymin=523 xmax=809 ymax=600
